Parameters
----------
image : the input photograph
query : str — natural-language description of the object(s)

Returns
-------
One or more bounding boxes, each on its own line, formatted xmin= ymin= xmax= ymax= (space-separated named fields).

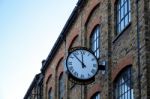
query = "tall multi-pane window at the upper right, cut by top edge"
xmin=117 ymin=0 xmax=131 ymax=34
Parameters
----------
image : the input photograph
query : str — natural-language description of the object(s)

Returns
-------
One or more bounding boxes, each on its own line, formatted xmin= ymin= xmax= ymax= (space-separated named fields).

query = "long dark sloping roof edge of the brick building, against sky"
xmin=41 ymin=0 xmax=85 ymax=74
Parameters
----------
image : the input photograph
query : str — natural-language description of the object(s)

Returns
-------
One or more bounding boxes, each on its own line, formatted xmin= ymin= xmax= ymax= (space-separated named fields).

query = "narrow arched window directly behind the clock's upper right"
xmin=91 ymin=25 xmax=100 ymax=58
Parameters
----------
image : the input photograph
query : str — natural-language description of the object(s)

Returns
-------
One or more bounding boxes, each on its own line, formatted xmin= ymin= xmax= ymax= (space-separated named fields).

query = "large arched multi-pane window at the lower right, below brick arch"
xmin=114 ymin=67 xmax=134 ymax=99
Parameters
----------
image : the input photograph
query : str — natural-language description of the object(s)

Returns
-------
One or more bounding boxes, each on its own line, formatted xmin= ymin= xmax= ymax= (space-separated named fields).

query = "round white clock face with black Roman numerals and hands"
xmin=66 ymin=49 xmax=98 ymax=80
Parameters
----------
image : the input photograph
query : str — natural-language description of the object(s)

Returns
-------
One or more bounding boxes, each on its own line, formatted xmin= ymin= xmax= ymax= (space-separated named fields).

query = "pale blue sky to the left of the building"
xmin=0 ymin=0 xmax=78 ymax=99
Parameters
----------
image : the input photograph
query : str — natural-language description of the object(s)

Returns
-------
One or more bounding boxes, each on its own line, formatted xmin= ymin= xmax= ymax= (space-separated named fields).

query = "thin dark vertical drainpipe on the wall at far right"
xmin=136 ymin=0 xmax=141 ymax=99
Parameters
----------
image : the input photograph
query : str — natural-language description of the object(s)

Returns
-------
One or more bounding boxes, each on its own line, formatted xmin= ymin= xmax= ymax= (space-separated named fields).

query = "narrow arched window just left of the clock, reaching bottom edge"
xmin=59 ymin=74 xmax=65 ymax=99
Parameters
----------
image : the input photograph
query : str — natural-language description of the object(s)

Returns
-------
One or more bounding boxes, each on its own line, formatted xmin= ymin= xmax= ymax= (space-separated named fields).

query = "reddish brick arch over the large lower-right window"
xmin=111 ymin=55 xmax=133 ymax=81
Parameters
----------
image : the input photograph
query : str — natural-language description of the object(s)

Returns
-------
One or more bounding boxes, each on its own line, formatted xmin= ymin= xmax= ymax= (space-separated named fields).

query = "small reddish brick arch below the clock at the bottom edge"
xmin=87 ymin=84 xmax=101 ymax=99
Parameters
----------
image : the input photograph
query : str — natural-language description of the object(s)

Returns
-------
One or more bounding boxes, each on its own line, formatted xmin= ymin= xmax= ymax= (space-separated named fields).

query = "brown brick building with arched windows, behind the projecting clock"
xmin=24 ymin=0 xmax=150 ymax=99
